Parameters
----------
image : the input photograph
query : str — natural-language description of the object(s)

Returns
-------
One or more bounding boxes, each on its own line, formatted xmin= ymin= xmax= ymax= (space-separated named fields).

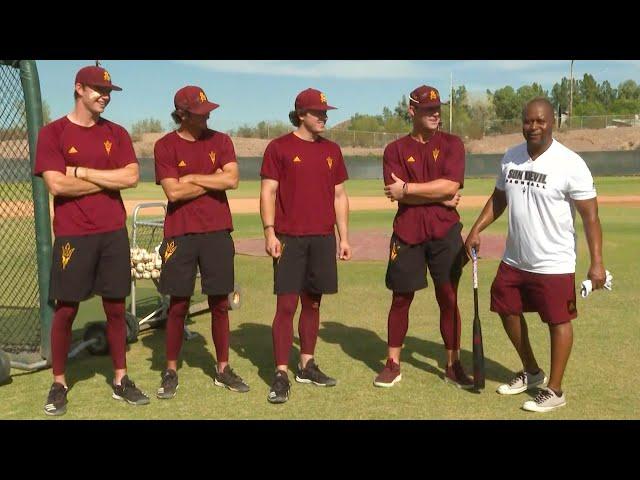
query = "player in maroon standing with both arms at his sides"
xmin=260 ymin=88 xmax=351 ymax=403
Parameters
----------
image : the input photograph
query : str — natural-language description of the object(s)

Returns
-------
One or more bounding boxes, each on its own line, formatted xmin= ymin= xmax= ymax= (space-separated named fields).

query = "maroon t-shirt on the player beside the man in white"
xmin=383 ymin=132 xmax=464 ymax=245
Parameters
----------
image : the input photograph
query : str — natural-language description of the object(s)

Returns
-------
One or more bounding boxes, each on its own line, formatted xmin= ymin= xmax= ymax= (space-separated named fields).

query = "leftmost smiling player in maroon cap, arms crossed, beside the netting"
xmin=34 ymin=66 xmax=149 ymax=415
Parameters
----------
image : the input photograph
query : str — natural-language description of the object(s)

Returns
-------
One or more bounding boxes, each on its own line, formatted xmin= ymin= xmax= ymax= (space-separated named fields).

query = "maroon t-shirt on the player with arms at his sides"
xmin=260 ymin=133 xmax=349 ymax=236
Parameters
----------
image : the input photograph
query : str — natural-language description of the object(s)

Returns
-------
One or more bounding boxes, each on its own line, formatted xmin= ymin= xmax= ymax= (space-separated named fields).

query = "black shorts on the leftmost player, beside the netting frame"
xmin=49 ymin=228 xmax=131 ymax=302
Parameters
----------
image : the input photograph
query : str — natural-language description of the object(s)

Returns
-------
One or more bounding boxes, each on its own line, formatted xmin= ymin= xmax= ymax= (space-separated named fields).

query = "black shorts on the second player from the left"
xmin=158 ymin=230 xmax=236 ymax=297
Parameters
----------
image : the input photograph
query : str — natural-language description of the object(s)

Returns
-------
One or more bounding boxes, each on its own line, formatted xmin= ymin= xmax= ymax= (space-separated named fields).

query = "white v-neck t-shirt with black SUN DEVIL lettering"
xmin=496 ymin=140 xmax=596 ymax=274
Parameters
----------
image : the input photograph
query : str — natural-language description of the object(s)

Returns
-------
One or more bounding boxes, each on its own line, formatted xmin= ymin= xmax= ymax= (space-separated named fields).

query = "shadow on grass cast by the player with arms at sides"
xmin=230 ymin=319 xmax=300 ymax=386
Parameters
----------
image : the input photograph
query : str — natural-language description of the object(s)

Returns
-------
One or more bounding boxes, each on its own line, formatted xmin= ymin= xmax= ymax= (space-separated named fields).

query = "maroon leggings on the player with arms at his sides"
xmin=272 ymin=292 xmax=322 ymax=366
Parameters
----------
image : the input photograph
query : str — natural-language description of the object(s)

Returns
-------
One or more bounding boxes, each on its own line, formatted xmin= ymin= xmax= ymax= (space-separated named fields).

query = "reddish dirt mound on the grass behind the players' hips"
xmin=234 ymin=230 xmax=506 ymax=260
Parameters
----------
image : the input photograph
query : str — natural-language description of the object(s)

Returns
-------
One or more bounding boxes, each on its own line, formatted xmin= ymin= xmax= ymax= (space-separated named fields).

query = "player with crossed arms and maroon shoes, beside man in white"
xmin=374 ymin=85 xmax=473 ymax=388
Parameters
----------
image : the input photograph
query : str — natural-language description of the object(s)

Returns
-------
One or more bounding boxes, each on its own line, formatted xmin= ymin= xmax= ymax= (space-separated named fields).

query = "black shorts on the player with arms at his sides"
xmin=273 ymin=234 xmax=338 ymax=295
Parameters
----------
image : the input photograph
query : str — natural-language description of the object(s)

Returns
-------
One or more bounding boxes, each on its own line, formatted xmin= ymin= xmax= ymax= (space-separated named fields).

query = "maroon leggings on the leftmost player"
xmin=51 ymin=298 xmax=127 ymax=375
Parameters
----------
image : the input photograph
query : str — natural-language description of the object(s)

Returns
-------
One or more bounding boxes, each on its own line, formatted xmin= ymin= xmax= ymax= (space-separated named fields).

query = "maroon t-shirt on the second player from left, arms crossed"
xmin=153 ymin=130 xmax=236 ymax=238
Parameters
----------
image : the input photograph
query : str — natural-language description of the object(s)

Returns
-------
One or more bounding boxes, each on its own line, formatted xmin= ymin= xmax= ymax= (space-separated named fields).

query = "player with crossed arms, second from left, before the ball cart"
xmin=154 ymin=85 xmax=249 ymax=399
